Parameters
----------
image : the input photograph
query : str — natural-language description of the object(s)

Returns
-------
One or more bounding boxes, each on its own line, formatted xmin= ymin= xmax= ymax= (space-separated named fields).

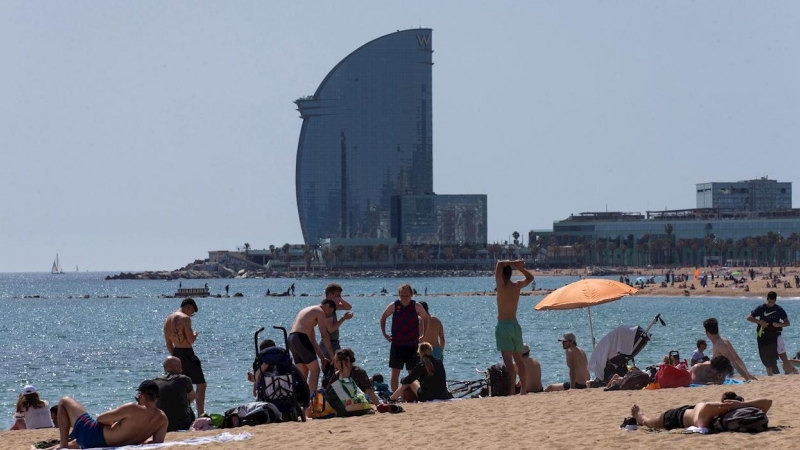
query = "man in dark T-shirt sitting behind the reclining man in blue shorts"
xmin=153 ymin=356 xmax=196 ymax=431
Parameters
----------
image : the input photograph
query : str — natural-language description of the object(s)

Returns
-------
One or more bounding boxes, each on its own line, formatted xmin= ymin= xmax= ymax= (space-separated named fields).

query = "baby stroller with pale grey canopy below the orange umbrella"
xmin=589 ymin=313 xmax=666 ymax=386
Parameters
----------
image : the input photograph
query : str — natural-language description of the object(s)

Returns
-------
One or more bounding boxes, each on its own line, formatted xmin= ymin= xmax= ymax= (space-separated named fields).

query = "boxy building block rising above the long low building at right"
xmin=697 ymin=178 xmax=792 ymax=211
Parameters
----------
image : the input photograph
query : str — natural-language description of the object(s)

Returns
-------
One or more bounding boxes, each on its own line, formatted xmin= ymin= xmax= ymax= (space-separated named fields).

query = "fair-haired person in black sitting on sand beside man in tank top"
xmin=389 ymin=342 xmax=453 ymax=402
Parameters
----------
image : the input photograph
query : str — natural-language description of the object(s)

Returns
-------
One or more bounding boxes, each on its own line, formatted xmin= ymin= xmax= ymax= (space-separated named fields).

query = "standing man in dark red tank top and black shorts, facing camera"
xmin=380 ymin=283 xmax=429 ymax=392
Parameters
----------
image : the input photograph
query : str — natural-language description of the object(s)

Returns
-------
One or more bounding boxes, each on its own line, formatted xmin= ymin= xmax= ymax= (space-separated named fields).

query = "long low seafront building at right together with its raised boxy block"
xmin=528 ymin=179 xmax=800 ymax=265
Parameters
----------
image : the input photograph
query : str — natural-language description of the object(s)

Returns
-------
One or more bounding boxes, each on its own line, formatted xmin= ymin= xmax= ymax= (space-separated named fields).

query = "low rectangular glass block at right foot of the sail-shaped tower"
xmin=392 ymin=194 xmax=487 ymax=245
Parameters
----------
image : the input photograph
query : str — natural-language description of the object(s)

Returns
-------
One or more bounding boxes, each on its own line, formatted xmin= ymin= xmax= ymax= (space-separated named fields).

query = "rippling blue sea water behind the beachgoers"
xmin=0 ymin=273 xmax=800 ymax=426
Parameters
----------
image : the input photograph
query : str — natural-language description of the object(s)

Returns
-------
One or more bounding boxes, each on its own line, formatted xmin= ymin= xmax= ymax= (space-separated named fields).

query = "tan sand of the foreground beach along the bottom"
xmin=0 ymin=376 xmax=800 ymax=450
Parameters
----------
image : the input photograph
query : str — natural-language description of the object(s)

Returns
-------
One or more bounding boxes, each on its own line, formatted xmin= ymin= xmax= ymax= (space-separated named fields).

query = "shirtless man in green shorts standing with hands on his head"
xmin=494 ymin=259 xmax=533 ymax=395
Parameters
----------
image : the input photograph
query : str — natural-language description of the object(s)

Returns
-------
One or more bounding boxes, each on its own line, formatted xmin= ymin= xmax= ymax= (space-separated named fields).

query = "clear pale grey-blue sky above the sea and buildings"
xmin=0 ymin=0 xmax=800 ymax=272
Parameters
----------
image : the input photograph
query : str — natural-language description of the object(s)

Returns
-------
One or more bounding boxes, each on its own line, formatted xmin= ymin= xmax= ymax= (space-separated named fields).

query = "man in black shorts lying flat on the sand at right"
xmin=631 ymin=392 xmax=772 ymax=430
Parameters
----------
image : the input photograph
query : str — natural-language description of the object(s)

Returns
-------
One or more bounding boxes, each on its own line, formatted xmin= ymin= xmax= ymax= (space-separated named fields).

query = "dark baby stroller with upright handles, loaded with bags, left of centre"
xmin=253 ymin=326 xmax=311 ymax=422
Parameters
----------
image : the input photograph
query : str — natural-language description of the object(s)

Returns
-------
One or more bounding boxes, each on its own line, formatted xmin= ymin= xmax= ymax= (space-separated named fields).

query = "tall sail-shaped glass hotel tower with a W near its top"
xmin=295 ymin=28 xmax=434 ymax=244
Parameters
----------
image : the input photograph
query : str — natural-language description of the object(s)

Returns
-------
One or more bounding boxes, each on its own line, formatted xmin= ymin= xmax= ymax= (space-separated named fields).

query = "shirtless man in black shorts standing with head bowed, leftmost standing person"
xmin=164 ymin=298 xmax=206 ymax=417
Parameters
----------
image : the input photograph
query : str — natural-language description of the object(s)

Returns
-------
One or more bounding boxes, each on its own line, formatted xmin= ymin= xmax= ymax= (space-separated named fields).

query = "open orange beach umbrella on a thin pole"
xmin=533 ymin=278 xmax=636 ymax=348
